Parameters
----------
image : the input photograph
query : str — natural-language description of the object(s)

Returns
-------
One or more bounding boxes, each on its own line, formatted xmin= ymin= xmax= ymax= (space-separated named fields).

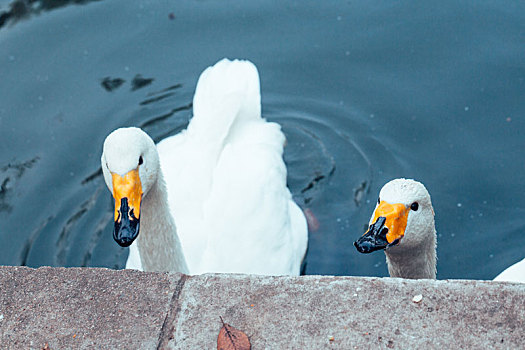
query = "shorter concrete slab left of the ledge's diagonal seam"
xmin=0 ymin=267 xmax=182 ymax=349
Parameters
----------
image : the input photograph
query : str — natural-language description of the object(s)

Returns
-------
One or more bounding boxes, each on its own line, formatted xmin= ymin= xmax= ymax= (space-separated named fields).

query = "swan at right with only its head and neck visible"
xmin=354 ymin=179 xmax=436 ymax=279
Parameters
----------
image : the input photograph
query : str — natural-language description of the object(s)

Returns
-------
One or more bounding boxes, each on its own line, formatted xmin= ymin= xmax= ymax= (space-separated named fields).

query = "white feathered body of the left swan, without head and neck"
xmin=157 ymin=59 xmax=307 ymax=274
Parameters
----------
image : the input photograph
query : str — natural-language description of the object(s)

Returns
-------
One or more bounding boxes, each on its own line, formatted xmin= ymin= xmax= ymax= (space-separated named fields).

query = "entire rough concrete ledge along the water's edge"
xmin=0 ymin=267 xmax=525 ymax=349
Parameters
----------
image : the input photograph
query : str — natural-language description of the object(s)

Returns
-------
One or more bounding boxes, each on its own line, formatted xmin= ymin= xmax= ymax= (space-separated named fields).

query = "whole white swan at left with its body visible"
xmin=101 ymin=59 xmax=308 ymax=275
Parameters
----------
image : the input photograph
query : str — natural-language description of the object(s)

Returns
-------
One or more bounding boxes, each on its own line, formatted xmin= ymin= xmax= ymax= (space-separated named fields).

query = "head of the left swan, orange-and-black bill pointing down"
xmin=100 ymin=128 xmax=160 ymax=247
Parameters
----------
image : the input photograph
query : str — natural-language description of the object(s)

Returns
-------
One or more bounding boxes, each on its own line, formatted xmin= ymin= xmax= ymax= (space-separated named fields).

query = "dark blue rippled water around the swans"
xmin=0 ymin=0 xmax=525 ymax=279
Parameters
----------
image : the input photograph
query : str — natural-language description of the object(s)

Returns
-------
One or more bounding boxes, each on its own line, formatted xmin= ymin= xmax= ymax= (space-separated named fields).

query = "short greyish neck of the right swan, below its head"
xmin=385 ymin=230 xmax=436 ymax=279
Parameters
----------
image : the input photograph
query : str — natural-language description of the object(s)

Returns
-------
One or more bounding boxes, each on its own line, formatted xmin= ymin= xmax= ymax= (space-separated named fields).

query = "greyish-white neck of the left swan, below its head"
xmin=137 ymin=169 xmax=189 ymax=273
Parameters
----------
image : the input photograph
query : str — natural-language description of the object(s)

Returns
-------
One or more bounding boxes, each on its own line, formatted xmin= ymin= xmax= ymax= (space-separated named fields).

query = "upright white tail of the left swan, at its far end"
xmin=188 ymin=58 xmax=261 ymax=147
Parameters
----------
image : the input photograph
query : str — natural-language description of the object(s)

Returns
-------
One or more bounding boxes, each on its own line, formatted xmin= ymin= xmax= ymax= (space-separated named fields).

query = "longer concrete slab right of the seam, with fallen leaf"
xmin=169 ymin=275 xmax=525 ymax=349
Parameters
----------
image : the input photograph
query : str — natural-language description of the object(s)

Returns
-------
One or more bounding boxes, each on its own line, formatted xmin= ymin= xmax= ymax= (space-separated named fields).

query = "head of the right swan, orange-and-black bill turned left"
xmin=354 ymin=179 xmax=436 ymax=253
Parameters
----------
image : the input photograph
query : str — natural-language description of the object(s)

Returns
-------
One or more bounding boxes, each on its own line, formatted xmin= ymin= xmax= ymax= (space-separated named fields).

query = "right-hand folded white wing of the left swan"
xmin=199 ymin=120 xmax=307 ymax=275
